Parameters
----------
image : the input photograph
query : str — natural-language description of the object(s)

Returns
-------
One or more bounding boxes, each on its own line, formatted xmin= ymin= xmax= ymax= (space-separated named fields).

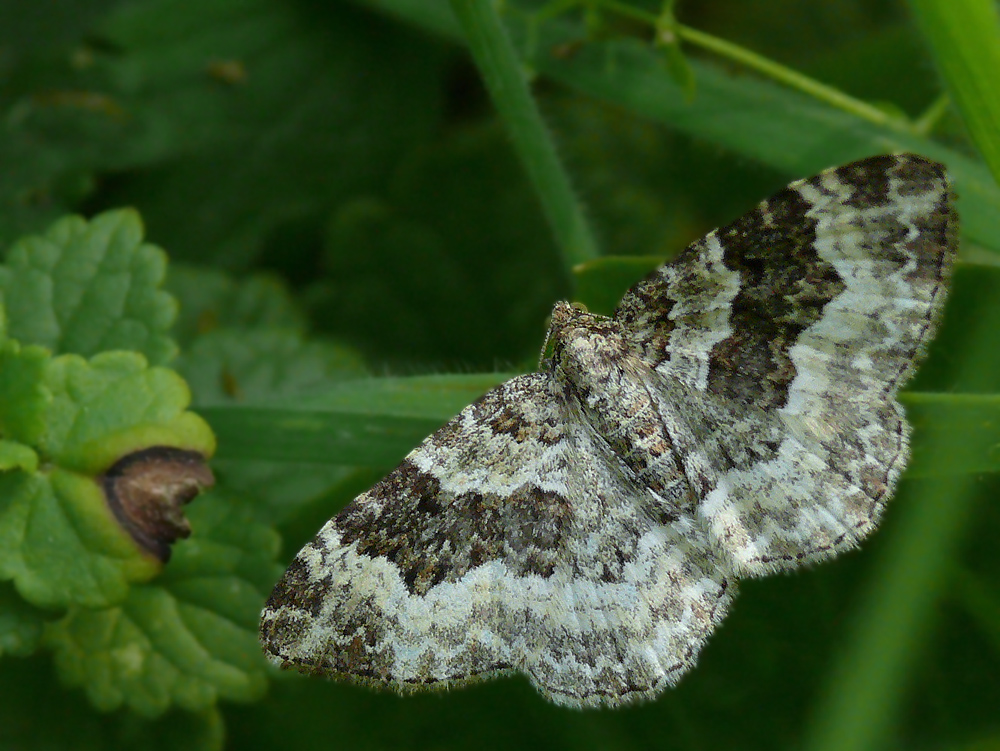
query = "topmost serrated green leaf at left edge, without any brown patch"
xmin=0 ymin=209 xmax=176 ymax=364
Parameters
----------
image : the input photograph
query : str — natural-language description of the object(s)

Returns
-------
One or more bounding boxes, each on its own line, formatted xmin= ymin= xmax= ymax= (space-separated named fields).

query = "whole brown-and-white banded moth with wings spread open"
xmin=260 ymin=154 xmax=957 ymax=707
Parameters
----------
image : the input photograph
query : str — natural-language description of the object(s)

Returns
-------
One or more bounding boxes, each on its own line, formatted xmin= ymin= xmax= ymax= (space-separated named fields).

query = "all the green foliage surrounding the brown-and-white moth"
xmin=0 ymin=0 xmax=1000 ymax=750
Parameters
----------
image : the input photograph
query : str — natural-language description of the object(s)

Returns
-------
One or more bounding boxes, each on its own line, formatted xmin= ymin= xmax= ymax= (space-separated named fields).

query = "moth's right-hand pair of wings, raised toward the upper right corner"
xmin=616 ymin=155 xmax=957 ymax=574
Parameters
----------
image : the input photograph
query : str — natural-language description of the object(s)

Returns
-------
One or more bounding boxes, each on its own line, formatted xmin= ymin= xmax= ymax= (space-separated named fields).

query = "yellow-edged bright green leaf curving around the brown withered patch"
xmin=0 ymin=350 xmax=214 ymax=607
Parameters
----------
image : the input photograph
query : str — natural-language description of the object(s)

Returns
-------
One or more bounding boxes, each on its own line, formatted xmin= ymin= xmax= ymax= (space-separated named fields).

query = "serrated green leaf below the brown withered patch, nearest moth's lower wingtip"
xmin=45 ymin=494 xmax=280 ymax=717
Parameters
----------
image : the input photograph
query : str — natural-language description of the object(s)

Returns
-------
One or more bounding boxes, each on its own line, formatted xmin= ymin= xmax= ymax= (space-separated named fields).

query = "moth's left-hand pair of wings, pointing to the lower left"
xmin=261 ymin=374 xmax=732 ymax=706
